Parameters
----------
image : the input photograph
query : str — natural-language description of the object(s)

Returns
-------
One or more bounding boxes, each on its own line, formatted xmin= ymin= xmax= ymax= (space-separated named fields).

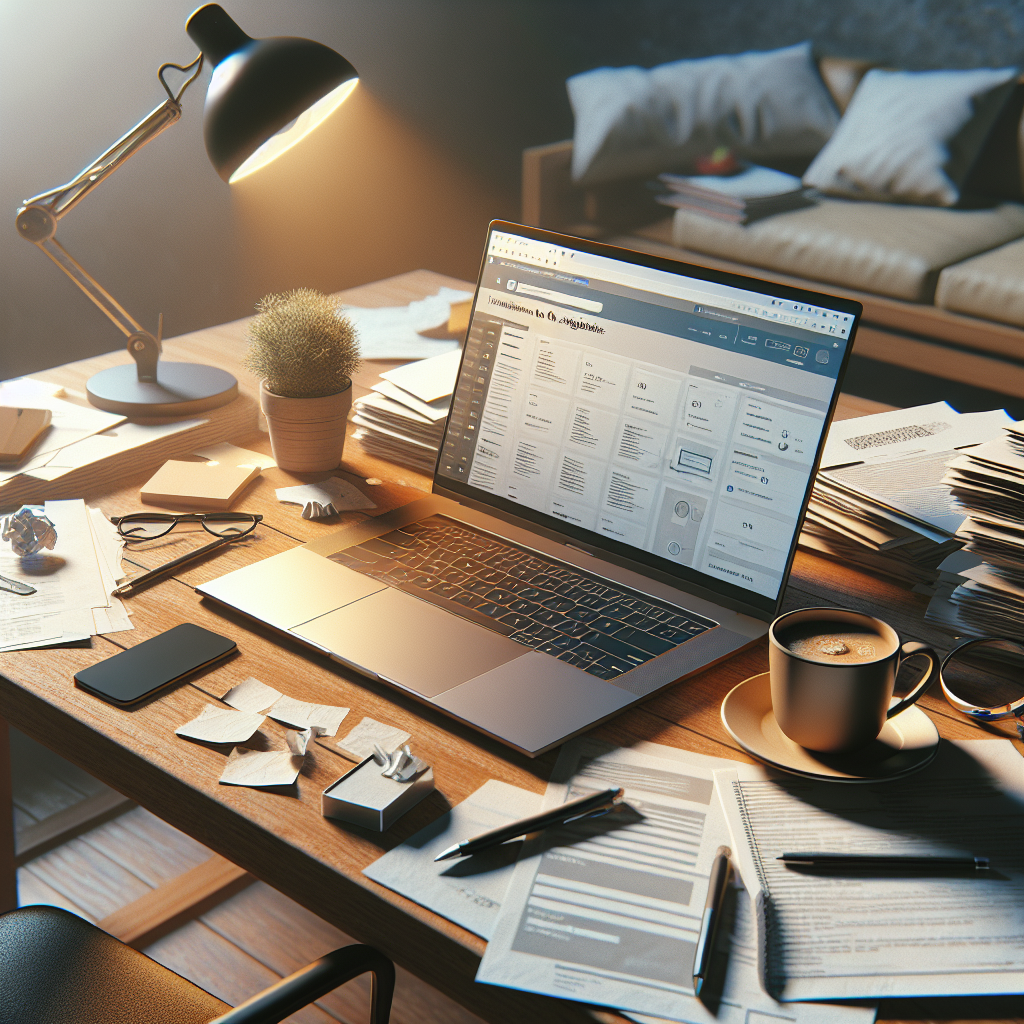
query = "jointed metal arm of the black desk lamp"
xmin=14 ymin=53 xmax=203 ymax=383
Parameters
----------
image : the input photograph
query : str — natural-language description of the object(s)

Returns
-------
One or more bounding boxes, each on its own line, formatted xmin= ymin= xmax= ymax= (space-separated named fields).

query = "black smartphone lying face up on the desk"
xmin=75 ymin=623 xmax=238 ymax=707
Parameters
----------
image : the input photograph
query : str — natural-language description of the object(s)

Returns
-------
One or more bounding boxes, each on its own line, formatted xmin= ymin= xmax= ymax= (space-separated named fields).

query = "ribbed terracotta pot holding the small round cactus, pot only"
xmin=259 ymin=381 xmax=352 ymax=473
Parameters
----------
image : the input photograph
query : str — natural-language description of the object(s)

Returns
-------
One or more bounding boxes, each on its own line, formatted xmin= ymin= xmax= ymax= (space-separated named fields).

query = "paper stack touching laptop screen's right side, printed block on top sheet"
xmin=800 ymin=401 xmax=1012 ymax=592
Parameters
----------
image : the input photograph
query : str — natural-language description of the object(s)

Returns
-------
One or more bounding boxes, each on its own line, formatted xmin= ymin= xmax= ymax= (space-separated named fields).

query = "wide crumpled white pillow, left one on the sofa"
xmin=565 ymin=43 xmax=839 ymax=183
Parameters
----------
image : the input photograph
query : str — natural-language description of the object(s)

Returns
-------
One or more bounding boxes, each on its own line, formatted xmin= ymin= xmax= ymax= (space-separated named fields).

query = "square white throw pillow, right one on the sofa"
xmin=804 ymin=68 xmax=1017 ymax=206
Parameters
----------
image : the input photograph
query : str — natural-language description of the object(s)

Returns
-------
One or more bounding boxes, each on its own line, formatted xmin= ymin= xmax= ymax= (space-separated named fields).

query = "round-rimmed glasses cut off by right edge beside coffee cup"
xmin=939 ymin=637 xmax=1024 ymax=739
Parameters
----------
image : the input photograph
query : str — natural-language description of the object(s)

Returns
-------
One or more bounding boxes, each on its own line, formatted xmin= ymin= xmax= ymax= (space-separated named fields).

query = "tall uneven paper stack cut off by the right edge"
xmin=929 ymin=422 xmax=1024 ymax=636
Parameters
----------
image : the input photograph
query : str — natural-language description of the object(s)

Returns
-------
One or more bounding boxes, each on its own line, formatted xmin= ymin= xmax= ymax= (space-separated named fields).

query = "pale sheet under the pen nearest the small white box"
xmin=362 ymin=779 xmax=542 ymax=939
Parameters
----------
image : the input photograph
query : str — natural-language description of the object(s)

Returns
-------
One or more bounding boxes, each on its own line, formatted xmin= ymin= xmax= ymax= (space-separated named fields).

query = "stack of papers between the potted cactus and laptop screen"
xmin=352 ymin=349 xmax=462 ymax=473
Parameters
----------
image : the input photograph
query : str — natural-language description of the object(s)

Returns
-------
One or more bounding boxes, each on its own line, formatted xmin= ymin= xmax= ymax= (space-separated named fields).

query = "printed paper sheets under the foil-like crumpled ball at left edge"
xmin=0 ymin=499 xmax=133 ymax=650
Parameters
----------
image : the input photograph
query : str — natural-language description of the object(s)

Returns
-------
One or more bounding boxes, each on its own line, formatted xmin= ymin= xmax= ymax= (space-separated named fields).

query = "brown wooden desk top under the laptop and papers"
xmin=0 ymin=271 xmax=1011 ymax=1024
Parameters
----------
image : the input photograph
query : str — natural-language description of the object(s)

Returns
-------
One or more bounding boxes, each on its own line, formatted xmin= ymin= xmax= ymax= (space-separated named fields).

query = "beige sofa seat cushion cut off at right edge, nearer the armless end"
xmin=935 ymin=239 xmax=1024 ymax=327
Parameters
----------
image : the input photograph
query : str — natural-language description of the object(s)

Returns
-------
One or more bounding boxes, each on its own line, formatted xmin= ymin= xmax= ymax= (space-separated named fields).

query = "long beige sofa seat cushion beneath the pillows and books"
xmin=673 ymin=199 xmax=1024 ymax=302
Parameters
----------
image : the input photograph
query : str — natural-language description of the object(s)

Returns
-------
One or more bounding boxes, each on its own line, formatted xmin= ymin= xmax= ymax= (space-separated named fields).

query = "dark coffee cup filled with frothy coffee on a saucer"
xmin=768 ymin=608 xmax=939 ymax=754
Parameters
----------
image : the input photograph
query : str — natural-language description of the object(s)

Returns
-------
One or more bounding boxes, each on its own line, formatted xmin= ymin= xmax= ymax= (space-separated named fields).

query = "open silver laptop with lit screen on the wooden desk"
xmin=198 ymin=221 xmax=861 ymax=756
